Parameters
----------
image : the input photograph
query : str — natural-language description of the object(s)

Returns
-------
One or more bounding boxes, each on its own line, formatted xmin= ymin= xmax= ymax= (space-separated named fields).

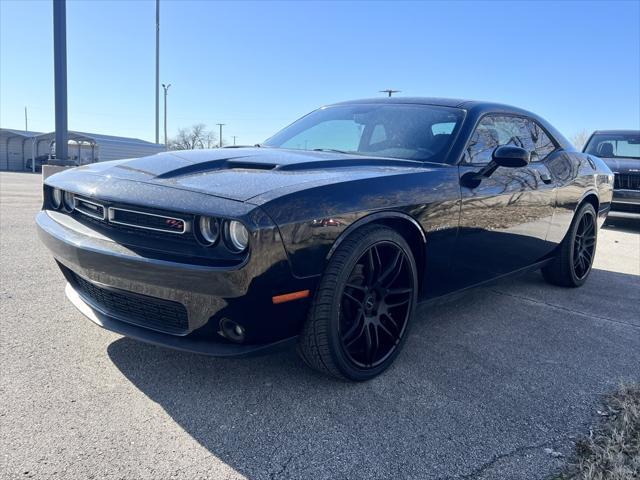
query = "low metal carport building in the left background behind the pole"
xmin=0 ymin=128 xmax=165 ymax=171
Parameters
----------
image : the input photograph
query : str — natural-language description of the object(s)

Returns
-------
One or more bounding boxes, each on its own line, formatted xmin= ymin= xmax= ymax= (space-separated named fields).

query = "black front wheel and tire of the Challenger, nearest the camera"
xmin=298 ymin=225 xmax=418 ymax=381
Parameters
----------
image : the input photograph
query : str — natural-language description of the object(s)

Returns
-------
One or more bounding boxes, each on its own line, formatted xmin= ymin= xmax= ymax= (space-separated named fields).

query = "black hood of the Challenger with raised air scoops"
xmin=74 ymin=148 xmax=436 ymax=201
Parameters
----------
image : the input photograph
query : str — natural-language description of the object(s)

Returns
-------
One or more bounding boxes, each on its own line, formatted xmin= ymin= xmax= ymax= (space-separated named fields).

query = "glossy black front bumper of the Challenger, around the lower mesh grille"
xmin=36 ymin=210 xmax=315 ymax=356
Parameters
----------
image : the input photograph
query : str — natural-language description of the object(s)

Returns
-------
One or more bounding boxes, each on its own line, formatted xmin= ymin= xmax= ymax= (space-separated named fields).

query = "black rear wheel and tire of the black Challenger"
xmin=542 ymin=203 xmax=598 ymax=288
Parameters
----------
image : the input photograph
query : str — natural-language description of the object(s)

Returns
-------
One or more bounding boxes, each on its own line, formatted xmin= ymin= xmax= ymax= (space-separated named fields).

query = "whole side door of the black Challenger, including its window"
xmin=455 ymin=116 xmax=556 ymax=288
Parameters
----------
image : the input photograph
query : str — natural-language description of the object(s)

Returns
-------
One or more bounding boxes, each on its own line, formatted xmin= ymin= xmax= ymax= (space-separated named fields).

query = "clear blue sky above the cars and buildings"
xmin=0 ymin=0 xmax=640 ymax=144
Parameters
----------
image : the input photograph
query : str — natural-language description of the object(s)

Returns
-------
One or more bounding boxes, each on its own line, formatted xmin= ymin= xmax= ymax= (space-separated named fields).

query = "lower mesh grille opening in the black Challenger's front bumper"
xmin=73 ymin=274 xmax=189 ymax=335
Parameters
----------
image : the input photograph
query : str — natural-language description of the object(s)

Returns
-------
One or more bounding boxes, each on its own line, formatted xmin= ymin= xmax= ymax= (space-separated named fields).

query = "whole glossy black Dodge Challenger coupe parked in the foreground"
xmin=37 ymin=98 xmax=613 ymax=380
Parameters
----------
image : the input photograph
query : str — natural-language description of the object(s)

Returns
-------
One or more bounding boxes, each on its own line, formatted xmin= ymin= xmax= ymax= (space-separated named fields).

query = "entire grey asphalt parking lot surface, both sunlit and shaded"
xmin=0 ymin=173 xmax=640 ymax=480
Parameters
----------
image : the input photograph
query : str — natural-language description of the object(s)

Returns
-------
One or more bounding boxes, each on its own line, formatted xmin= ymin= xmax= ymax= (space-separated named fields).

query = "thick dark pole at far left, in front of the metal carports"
xmin=53 ymin=0 xmax=69 ymax=165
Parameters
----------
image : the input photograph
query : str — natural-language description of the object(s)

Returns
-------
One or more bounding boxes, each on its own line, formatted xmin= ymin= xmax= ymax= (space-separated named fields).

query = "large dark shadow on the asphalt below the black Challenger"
xmin=108 ymin=270 xmax=640 ymax=479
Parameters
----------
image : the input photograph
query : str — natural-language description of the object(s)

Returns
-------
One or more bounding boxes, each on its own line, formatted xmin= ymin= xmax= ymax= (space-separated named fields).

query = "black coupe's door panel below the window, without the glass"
xmin=456 ymin=163 xmax=555 ymax=286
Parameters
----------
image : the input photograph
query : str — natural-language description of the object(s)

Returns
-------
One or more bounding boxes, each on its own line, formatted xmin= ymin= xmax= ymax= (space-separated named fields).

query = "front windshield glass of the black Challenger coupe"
xmin=263 ymin=104 xmax=464 ymax=163
